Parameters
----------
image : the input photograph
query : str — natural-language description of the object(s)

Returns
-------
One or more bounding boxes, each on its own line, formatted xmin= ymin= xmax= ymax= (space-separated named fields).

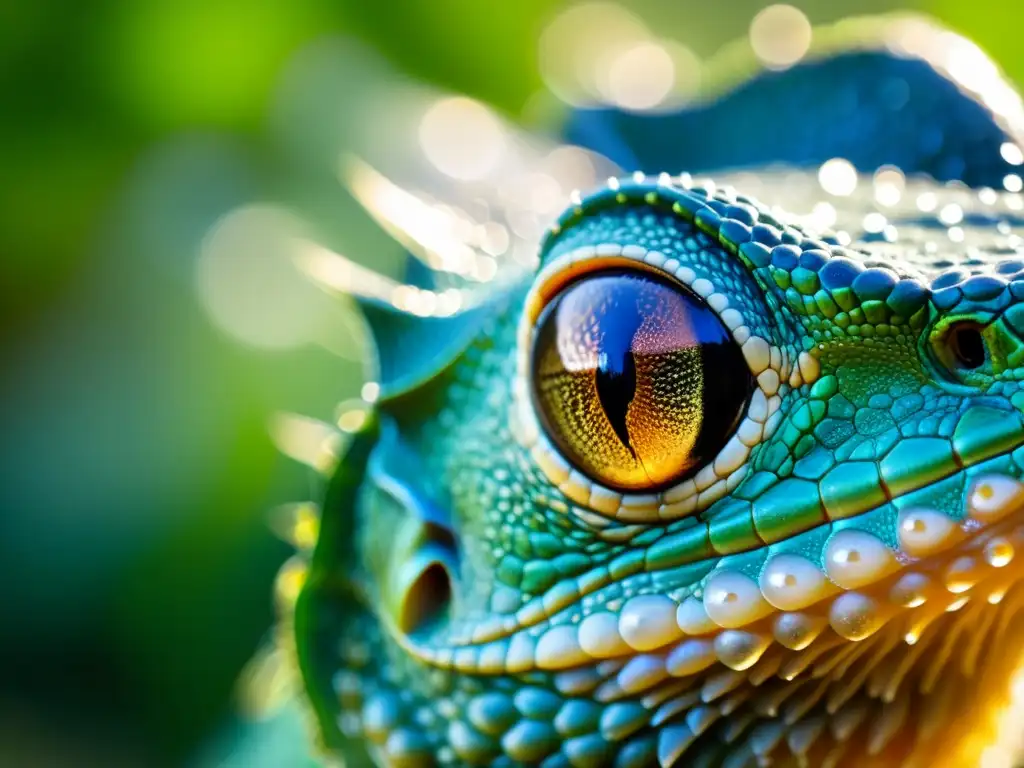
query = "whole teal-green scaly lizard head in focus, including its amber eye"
xmin=297 ymin=177 xmax=1024 ymax=765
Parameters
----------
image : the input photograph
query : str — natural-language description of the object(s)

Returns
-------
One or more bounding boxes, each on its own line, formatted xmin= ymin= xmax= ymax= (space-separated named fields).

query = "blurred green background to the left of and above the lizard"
xmin=0 ymin=0 xmax=1024 ymax=766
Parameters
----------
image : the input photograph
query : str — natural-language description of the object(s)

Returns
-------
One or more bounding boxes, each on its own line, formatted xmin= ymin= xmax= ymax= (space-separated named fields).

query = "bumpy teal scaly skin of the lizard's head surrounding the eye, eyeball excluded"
xmin=280 ymin=13 xmax=1024 ymax=766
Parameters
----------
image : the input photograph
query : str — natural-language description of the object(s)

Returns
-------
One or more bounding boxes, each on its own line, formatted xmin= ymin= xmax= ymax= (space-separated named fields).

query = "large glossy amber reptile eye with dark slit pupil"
xmin=532 ymin=270 xmax=754 ymax=490
